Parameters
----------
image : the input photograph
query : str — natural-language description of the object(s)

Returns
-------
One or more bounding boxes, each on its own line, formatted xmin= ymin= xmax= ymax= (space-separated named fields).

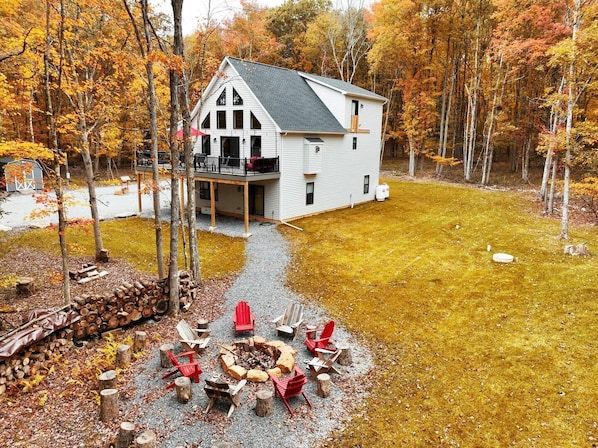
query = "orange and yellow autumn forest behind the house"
xmin=0 ymin=0 xmax=598 ymax=228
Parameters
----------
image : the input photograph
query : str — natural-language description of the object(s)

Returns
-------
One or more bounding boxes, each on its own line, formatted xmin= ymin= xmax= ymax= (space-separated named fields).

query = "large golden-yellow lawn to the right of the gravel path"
xmin=282 ymin=180 xmax=598 ymax=447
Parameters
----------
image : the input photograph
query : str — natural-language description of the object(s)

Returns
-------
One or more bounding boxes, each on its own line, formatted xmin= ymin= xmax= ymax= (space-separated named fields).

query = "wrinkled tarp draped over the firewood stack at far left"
xmin=0 ymin=310 xmax=80 ymax=360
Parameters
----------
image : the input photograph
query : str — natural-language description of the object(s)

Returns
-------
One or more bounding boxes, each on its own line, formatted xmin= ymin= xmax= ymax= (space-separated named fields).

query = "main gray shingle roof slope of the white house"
xmin=227 ymin=57 xmax=352 ymax=134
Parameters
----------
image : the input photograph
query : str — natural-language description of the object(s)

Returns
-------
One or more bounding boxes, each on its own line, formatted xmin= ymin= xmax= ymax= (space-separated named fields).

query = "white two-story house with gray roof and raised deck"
xmin=186 ymin=57 xmax=386 ymax=232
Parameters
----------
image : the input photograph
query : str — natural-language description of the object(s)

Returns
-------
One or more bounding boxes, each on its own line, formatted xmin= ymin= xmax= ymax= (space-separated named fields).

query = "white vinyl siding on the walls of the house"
xmin=192 ymin=57 xmax=382 ymax=221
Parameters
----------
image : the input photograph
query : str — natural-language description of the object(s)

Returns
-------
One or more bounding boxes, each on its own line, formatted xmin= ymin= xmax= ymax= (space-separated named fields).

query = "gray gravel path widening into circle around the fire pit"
xmin=125 ymin=216 xmax=371 ymax=448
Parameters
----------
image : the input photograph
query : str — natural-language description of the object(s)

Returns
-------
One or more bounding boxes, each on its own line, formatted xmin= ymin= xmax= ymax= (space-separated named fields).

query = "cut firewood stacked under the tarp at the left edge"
xmin=0 ymin=328 xmax=73 ymax=395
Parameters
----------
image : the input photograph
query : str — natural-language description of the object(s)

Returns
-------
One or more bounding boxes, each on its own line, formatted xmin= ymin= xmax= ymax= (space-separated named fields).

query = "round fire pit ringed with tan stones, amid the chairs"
xmin=219 ymin=336 xmax=297 ymax=383
